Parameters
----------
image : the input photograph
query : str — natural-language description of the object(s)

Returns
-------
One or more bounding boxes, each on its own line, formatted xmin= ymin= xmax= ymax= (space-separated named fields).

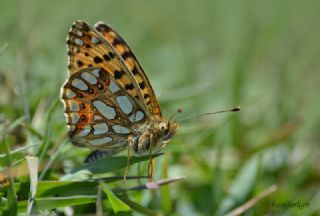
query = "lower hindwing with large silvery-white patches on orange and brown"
xmin=61 ymin=67 xmax=148 ymax=155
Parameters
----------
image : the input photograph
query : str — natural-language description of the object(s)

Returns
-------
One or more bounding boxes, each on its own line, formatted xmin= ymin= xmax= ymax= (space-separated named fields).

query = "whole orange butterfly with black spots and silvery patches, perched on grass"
xmin=61 ymin=21 xmax=179 ymax=176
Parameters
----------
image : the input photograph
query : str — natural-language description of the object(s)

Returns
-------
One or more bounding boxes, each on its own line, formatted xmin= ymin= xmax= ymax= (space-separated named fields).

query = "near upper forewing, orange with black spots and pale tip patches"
xmin=67 ymin=21 xmax=150 ymax=116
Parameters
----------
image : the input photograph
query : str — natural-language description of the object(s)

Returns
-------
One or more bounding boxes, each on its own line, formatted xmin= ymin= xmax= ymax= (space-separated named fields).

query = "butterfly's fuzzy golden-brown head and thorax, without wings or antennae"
xmin=131 ymin=118 xmax=179 ymax=154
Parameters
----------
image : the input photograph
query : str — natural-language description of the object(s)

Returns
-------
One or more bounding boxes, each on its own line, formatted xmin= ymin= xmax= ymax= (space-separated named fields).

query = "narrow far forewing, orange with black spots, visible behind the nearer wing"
xmin=94 ymin=22 xmax=161 ymax=117
